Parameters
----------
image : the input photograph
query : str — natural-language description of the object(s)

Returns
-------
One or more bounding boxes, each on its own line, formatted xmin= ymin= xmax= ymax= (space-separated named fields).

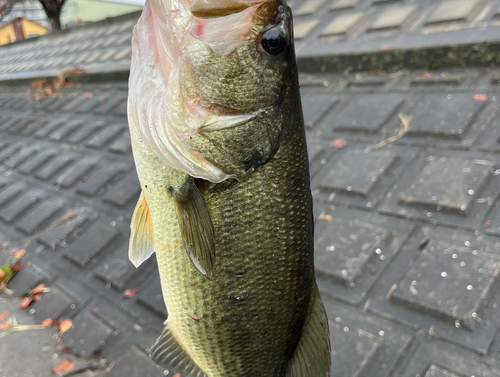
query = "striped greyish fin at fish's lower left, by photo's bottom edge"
xmin=149 ymin=326 xmax=207 ymax=377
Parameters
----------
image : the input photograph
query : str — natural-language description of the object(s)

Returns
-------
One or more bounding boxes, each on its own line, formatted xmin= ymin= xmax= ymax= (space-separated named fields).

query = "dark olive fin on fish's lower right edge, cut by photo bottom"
xmin=286 ymin=286 xmax=330 ymax=377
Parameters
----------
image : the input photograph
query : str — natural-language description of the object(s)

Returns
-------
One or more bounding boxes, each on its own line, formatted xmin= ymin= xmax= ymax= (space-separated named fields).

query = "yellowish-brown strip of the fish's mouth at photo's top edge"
xmin=190 ymin=0 xmax=267 ymax=18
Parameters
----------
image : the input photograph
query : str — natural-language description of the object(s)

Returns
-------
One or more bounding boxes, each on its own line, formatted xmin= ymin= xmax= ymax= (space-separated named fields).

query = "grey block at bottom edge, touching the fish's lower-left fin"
xmin=107 ymin=346 xmax=165 ymax=377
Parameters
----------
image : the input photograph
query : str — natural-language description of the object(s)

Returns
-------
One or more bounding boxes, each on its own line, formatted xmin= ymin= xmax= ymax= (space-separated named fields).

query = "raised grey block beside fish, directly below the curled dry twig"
xmin=320 ymin=149 xmax=396 ymax=196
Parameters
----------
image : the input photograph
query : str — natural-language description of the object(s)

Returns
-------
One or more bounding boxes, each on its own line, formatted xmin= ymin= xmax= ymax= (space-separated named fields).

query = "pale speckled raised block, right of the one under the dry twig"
xmin=401 ymin=156 xmax=492 ymax=212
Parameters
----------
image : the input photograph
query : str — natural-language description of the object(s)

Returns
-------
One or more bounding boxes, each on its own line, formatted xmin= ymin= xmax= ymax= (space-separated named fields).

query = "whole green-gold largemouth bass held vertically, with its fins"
xmin=128 ymin=0 xmax=330 ymax=377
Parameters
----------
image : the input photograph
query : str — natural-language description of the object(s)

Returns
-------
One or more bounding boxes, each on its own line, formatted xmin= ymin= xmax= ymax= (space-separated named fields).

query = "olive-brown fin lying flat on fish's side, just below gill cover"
xmin=173 ymin=178 xmax=215 ymax=279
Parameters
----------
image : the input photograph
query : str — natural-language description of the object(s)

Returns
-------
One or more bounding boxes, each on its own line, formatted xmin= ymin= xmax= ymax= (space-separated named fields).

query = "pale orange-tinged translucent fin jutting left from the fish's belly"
xmin=128 ymin=192 xmax=154 ymax=267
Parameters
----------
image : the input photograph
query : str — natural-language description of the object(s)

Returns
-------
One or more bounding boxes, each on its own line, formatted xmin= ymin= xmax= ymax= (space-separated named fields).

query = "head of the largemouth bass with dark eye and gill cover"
xmin=129 ymin=0 xmax=300 ymax=182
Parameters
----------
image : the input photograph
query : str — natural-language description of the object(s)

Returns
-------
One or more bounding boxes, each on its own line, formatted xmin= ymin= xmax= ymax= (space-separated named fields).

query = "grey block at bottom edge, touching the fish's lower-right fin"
xmin=330 ymin=324 xmax=381 ymax=377
